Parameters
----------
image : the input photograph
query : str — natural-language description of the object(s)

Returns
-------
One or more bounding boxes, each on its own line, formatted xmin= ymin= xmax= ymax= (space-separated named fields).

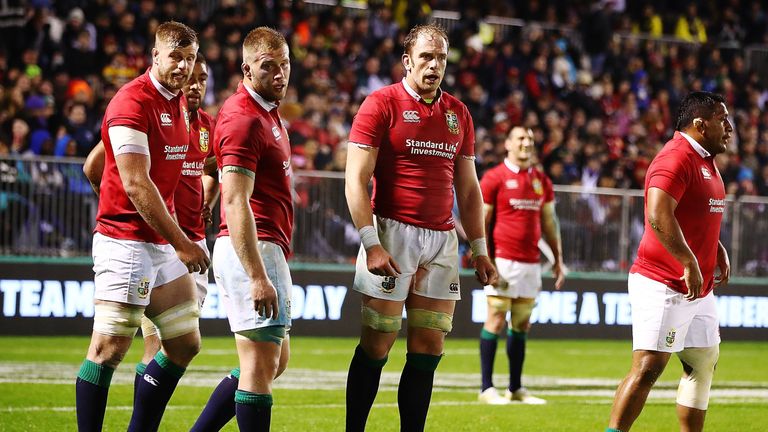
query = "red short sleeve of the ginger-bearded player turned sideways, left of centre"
xmin=214 ymin=116 xmax=265 ymax=172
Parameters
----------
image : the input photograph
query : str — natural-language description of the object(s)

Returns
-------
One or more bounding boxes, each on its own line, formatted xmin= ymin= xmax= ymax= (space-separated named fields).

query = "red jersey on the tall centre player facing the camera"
xmin=349 ymin=80 xmax=475 ymax=231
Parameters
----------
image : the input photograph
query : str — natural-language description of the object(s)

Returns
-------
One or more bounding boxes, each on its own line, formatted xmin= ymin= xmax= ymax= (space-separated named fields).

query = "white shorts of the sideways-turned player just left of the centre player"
xmin=213 ymin=236 xmax=293 ymax=333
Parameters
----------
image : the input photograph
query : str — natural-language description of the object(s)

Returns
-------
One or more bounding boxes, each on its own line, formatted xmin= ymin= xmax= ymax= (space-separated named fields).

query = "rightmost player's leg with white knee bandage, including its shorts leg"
xmin=677 ymin=293 xmax=720 ymax=432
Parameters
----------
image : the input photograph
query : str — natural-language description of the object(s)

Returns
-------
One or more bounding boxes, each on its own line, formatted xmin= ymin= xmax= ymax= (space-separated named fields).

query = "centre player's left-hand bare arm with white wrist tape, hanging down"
xmin=344 ymin=143 xmax=400 ymax=276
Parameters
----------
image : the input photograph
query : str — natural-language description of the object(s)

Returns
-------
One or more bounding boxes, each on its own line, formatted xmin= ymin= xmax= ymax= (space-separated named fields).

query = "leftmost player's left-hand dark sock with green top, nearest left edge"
xmin=75 ymin=360 xmax=115 ymax=431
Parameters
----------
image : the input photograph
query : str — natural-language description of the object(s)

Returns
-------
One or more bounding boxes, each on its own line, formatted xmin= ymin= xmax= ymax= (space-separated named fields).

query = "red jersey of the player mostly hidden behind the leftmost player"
xmin=173 ymin=108 xmax=214 ymax=241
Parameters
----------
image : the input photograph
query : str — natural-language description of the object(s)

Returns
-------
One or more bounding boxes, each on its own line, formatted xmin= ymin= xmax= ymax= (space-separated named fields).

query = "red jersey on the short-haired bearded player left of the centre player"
xmin=213 ymin=82 xmax=293 ymax=256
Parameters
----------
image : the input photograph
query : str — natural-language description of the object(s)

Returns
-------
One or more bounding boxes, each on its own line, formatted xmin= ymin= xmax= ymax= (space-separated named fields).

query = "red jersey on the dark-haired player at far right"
xmin=630 ymin=132 xmax=725 ymax=297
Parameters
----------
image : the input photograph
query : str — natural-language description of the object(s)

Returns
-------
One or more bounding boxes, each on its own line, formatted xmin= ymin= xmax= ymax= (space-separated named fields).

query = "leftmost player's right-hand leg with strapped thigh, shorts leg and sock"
xmin=128 ymin=245 xmax=200 ymax=432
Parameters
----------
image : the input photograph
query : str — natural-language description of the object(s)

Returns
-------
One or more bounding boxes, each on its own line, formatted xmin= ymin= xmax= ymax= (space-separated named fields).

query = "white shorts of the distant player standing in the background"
xmin=483 ymin=258 xmax=541 ymax=298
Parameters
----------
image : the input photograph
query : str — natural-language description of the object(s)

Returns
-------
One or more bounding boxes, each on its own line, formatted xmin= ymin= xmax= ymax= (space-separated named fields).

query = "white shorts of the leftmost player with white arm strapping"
xmin=93 ymin=233 xmax=188 ymax=307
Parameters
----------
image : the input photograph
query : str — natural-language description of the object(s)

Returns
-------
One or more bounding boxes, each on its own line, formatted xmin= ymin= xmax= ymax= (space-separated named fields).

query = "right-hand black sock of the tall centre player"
xmin=397 ymin=353 xmax=442 ymax=432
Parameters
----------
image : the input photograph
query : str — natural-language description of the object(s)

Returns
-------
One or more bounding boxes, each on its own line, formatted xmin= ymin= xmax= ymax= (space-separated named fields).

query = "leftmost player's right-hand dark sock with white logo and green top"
xmin=128 ymin=351 xmax=186 ymax=432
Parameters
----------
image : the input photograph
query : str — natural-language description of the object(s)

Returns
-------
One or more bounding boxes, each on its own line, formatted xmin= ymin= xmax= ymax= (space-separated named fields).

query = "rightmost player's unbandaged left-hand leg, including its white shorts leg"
xmin=609 ymin=273 xmax=698 ymax=432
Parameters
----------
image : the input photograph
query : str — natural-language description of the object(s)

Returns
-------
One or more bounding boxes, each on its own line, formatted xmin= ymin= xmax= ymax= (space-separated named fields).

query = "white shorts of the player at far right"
xmin=628 ymin=273 xmax=720 ymax=352
